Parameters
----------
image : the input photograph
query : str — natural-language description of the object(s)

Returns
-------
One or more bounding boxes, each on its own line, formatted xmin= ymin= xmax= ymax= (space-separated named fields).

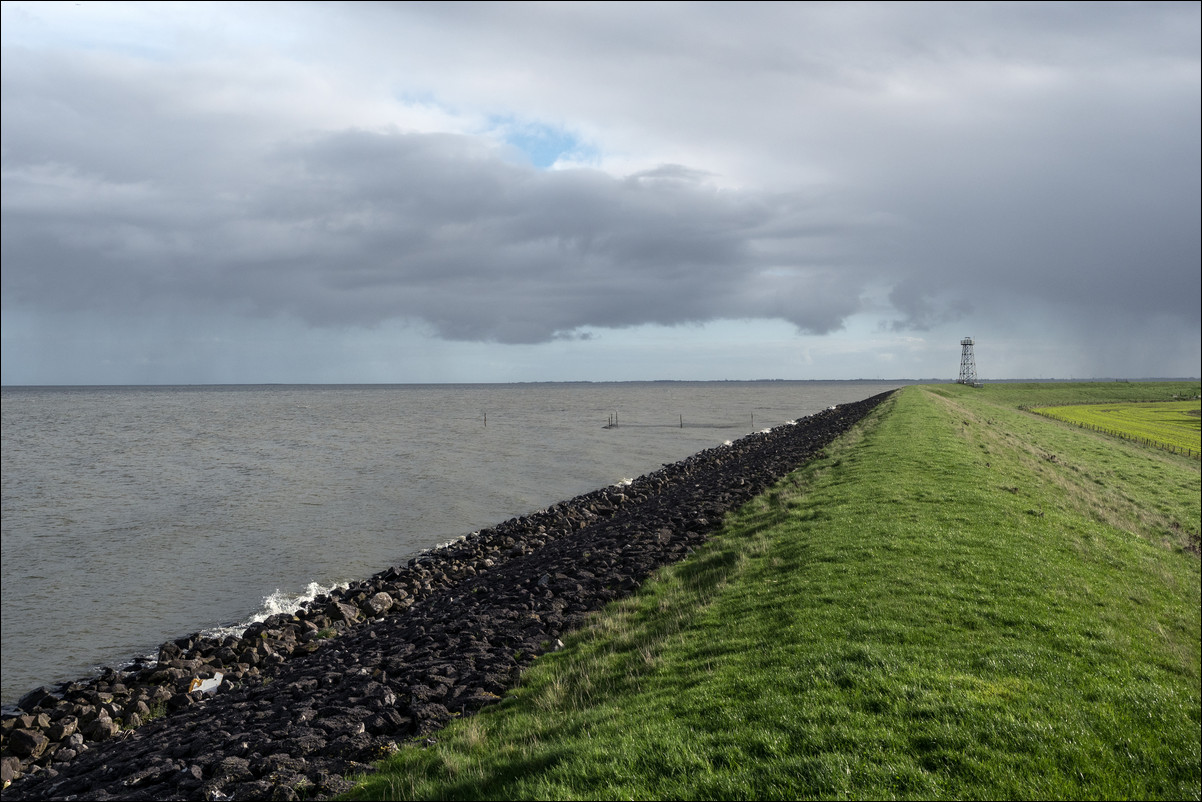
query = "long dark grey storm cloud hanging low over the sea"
xmin=4 ymin=119 xmax=858 ymax=343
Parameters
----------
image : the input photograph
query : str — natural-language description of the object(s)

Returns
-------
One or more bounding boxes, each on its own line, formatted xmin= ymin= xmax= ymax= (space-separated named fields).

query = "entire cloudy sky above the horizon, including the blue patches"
xmin=0 ymin=1 xmax=1202 ymax=385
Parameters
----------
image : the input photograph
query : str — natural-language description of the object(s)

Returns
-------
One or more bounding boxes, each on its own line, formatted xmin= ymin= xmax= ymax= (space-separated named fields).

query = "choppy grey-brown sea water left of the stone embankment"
xmin=0 ymin=381 xmax=897 ymax=705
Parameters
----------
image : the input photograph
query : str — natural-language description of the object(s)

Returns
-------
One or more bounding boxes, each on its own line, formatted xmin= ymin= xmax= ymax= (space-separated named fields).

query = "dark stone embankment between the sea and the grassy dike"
xmin=2 ymin=393 xmax=888 ymax=800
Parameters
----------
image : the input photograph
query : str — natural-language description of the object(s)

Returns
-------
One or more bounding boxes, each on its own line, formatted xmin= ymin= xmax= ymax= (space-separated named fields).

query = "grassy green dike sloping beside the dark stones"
xmin=343 ymin=385 xmax=1202 ymax=800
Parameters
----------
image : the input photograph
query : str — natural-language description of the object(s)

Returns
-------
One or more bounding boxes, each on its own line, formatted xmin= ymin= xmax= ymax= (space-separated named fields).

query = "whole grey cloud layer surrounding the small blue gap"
xmin=0 ymin=4 xmax=1202 ymax=353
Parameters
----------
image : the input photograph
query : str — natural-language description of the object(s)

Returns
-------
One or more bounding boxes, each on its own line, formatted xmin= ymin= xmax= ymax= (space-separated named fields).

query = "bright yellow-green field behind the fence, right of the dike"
xmin=1031 ymin=399 xmax=1202 ymax=457
